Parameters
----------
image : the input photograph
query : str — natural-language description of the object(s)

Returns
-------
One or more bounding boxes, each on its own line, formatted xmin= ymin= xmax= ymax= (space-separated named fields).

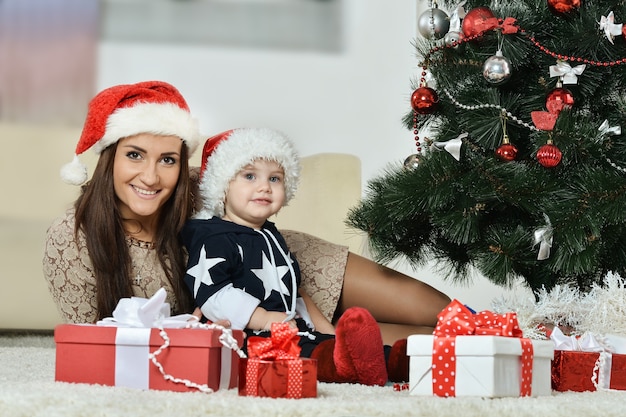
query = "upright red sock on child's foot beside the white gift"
xmin=333 ymin=307 xmax=387 ymax=385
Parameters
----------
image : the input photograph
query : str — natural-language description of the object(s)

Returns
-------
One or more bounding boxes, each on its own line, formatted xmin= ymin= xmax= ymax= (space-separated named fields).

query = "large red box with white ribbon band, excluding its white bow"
xmin=54 ymin=324 xmax=243 ymax=391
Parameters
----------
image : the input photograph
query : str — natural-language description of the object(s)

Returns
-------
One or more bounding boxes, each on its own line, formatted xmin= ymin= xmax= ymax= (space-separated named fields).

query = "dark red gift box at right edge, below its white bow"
xmin=552 ymin=350 xmax=626 ymax=392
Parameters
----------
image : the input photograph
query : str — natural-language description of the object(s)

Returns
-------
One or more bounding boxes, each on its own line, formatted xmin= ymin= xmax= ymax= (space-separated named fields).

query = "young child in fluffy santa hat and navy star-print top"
xmin=182 ymin=128 xmax=406 ymax=385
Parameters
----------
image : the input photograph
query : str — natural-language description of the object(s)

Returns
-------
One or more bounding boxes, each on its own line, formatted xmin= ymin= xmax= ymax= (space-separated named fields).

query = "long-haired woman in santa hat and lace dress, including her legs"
xmin=43 ymin=82 xmax=449 ymax=345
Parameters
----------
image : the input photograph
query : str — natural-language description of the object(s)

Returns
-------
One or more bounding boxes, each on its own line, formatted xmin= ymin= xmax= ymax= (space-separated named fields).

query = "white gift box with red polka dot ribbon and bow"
xmin=407 ymin=300 xmax=554 ymax=398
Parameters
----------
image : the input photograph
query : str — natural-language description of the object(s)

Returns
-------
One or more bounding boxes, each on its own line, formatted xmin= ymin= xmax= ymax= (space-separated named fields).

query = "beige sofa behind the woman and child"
xmin=0 ymin=124 xmax=362 ymax=330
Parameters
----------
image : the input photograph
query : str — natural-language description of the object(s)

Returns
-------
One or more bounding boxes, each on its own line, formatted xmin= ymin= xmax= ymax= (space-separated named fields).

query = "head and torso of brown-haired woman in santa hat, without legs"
xmin=43 ymin=82 xmax=200 ymax=323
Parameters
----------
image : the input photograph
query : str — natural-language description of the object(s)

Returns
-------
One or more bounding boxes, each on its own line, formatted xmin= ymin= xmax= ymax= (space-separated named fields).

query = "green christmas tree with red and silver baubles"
xmin=346 ymin=0 xmax=626 ymax=292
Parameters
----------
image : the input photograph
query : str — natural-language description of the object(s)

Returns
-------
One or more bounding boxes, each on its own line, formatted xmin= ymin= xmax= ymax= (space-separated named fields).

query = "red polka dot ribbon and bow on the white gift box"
xmin=432 ymin=300 xmax=533 ymax=397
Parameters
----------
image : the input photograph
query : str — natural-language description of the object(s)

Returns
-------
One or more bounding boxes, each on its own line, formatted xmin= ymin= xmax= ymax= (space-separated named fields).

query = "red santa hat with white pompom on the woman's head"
xmin=61 ymin=81 xmax=200 ymax=185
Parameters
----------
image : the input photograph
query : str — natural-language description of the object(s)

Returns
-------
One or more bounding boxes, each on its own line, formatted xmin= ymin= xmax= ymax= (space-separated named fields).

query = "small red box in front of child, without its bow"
xmin=239 ymin=358 xmax=317 ymax=398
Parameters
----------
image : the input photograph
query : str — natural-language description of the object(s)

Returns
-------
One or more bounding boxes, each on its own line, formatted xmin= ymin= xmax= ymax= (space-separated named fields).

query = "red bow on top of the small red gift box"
xmin=248 ymin=323 xmax=301 ymax=359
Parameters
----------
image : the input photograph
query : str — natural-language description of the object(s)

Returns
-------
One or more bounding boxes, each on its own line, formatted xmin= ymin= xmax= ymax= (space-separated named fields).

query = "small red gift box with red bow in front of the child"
xmin=239 ymin=323 xmax=317 ymax=398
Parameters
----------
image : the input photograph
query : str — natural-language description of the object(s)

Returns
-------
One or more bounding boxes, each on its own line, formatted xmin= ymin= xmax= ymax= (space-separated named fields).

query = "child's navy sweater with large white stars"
xmin=181 ymin=217 xmax=313 ymax=330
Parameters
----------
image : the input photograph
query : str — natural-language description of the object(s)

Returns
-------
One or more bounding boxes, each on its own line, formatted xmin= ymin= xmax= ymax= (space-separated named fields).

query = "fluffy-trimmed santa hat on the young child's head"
xmin=195 ymin=128 xmax=300 ymax=219
